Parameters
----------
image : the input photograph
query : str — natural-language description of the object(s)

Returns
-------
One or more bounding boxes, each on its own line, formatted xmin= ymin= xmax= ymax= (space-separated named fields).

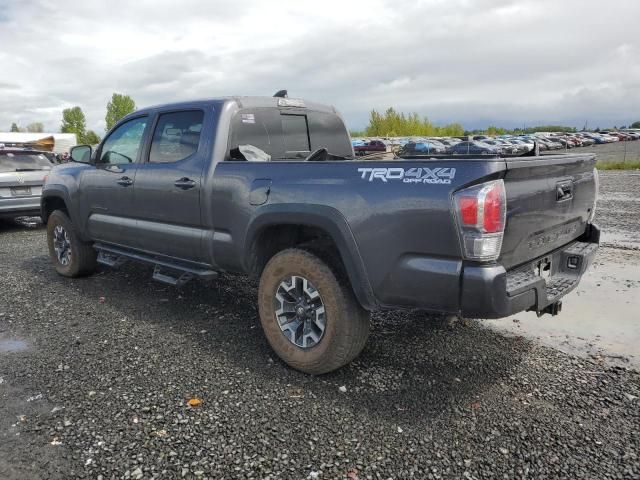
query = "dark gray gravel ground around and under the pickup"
xmin=0 ymin=171 xmax=640 ymax=480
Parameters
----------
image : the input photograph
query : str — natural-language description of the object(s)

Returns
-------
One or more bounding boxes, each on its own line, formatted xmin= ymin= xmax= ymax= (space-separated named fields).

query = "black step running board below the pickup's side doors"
xmin=93 ymin=243 xmax=218 ymax=286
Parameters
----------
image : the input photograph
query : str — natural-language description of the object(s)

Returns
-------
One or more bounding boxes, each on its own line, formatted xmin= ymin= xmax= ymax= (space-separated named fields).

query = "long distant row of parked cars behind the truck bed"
xmin=352 ymin=132 xmax=640 ymax=156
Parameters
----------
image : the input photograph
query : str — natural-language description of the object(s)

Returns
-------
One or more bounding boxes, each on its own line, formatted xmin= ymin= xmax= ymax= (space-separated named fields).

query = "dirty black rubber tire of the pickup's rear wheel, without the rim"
xmin=258 ymin=248 xmax=370 ymax=375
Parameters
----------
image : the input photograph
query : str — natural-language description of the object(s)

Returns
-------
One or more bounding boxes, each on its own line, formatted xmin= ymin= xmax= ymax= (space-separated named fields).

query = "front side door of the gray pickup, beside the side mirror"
xmin=79 ymin=116 xmax=148 ymax=247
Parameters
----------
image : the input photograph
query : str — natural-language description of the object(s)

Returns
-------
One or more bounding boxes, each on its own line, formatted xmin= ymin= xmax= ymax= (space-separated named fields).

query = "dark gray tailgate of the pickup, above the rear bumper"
xmin=498 ymin=154 xmax=596 ymax=269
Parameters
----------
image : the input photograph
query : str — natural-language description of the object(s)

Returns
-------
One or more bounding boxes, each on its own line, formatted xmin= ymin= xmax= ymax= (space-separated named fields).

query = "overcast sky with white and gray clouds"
xmin=0 ymin=0 xmax=640 ymax=135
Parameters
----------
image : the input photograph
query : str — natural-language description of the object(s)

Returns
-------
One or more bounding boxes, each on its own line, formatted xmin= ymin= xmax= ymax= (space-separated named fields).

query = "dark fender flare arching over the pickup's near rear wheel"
xmin=242 ymin=203 xmax=378 ymax=310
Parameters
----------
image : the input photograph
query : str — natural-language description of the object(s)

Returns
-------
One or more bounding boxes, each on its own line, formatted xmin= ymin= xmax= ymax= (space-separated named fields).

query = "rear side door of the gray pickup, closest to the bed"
xmin=134 ymin=109 xmax=206 ymax=262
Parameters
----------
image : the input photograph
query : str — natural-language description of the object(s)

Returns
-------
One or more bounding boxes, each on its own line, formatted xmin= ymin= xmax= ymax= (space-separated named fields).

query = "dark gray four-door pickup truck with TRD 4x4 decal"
xmin=41 ymin=96 xmax=599 ymax=374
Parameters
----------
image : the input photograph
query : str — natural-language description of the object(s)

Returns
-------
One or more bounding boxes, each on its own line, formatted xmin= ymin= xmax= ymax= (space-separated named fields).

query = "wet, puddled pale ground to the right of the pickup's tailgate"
xmin=484 ymin=171 xmax=640 ymax=369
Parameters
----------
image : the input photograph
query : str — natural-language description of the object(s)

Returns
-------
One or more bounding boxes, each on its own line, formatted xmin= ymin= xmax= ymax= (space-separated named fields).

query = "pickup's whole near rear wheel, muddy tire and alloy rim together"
xmin=258 ymin=248 xmax=369 ymax=374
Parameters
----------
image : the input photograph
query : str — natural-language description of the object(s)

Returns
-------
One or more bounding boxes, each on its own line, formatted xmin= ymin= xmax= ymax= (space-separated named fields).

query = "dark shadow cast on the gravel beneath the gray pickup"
xmin=24 ymin=256 xmax=531 ymax=421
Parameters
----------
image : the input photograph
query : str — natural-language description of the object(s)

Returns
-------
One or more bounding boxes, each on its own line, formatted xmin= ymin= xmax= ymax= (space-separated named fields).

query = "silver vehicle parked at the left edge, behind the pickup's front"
xmin=0 ymin=146 xmax=53 ymax=218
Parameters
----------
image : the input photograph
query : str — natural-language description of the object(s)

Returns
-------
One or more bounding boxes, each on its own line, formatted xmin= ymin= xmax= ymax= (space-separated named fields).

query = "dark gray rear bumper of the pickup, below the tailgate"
xmin=460 ymin=225 xmax=600 ymax=318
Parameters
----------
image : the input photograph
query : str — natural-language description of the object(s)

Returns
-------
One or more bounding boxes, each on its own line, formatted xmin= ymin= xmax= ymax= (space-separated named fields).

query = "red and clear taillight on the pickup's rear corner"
xmin=454 ymin=180 xmax=507 ymax=261
